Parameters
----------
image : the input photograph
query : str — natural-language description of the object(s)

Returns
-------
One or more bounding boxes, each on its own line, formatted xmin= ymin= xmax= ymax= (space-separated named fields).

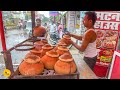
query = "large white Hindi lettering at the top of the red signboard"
xmin=95 ymin=11 xmax=120 ymax=30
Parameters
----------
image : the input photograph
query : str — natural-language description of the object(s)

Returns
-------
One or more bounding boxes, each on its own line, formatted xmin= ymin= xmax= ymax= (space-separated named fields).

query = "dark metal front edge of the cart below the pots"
xmin=9 ymin=63 xmax=79 ymax=79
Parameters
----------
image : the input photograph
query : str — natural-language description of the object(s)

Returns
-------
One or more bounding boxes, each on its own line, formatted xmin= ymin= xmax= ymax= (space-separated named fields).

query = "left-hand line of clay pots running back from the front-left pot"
xmin=19 ymin=39 xmax=48 ymax=76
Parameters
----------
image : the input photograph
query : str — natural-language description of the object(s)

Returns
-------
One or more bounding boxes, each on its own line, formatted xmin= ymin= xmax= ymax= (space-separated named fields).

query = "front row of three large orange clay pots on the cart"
xmin=19 ymin=50 xmax=76 ymax=76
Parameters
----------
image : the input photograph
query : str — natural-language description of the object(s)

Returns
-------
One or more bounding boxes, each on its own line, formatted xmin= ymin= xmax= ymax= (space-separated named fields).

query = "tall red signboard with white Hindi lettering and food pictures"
xmin=94 ymin=11 xmax=120 ymax=77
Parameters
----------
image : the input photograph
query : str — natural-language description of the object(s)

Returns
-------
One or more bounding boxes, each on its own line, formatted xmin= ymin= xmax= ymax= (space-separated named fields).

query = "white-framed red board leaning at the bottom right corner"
xmin=108 ymin=51 xmax=120 ymax=79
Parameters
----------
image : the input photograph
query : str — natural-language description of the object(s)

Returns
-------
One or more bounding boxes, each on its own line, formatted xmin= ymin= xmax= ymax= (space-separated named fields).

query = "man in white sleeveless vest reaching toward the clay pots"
xmin=67 ymin=12 xmax=97 ymax=70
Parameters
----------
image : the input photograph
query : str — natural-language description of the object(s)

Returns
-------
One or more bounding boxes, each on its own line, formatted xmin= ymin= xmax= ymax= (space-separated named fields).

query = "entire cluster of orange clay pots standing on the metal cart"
xmin=19 ymin=35 xmax=76 ymax=76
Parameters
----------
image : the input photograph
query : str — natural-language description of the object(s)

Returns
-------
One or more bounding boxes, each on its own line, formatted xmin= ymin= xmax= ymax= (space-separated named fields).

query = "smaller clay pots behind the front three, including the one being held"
xmin=28 ymin=35 xmax=70 ymax=57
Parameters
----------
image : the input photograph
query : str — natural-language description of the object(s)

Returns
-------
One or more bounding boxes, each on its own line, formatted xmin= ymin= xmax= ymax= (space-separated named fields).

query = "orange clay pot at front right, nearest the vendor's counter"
xmin=54 ymin=54 xmax=77 ymax=74
